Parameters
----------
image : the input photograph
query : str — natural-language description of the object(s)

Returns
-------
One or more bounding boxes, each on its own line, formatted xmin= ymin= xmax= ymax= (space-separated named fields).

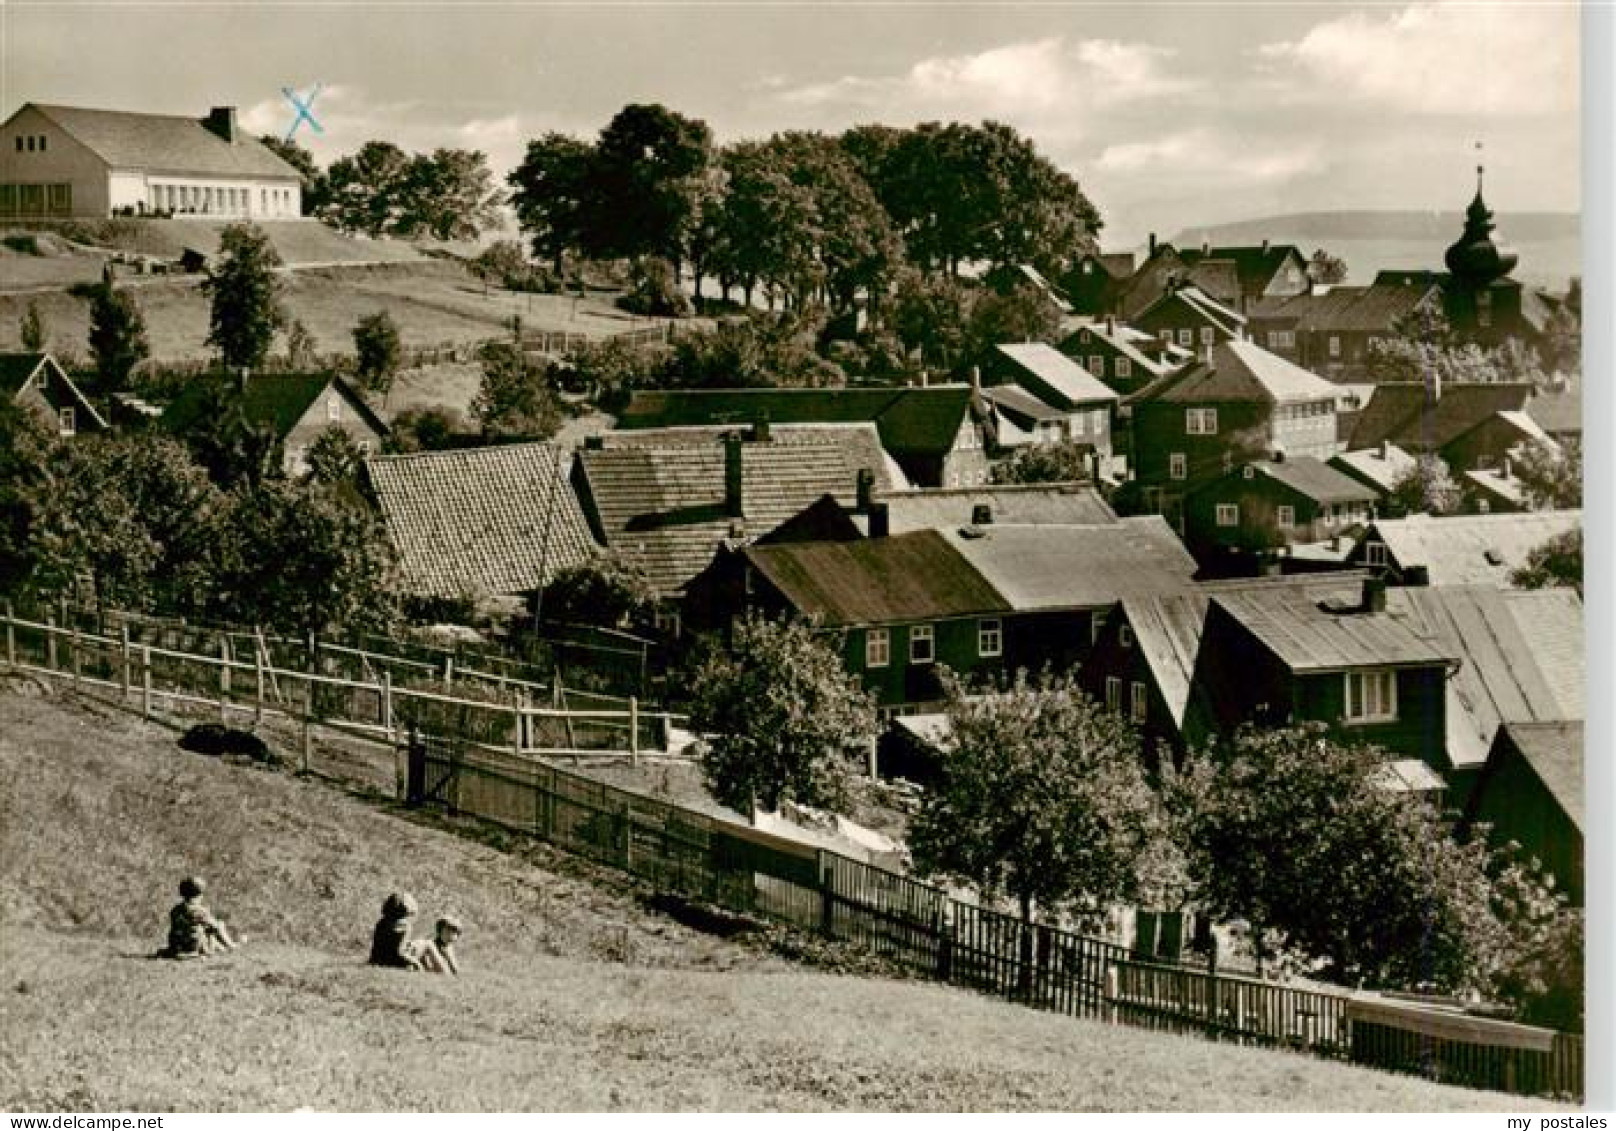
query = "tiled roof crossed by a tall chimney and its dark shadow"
xmin=579 ymin=441 xmax=885 ymax=595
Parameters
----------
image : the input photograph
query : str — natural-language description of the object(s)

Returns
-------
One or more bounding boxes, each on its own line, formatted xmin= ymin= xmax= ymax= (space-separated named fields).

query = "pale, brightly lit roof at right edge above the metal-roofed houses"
xmin=1362 ymin=511 xmax=1582 ymax=588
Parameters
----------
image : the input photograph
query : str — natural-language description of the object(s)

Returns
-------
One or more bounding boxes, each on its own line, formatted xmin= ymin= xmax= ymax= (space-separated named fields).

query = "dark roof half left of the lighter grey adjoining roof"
xmin=743 ymin=530 xmax=1010 ymax=627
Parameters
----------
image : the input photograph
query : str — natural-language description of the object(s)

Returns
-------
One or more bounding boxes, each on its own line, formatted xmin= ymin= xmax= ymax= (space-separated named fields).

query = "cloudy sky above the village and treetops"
xmin=0 ymin=0 xmax=1582 ymax=247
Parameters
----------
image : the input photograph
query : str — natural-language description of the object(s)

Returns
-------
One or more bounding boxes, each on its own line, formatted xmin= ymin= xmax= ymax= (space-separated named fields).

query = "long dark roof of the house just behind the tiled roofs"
xmin=617 ymin=385 xmax=971 ymax=459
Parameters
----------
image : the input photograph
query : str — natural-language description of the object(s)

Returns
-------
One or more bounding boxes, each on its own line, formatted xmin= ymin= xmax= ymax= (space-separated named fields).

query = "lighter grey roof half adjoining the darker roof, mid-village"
xmin=944 ymin=515 xmax=1196 ymax=612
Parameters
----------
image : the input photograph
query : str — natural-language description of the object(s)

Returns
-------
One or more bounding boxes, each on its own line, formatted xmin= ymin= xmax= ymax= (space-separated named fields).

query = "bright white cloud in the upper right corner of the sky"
xmin=1256 ymin=3 xmax=1579 ymax=116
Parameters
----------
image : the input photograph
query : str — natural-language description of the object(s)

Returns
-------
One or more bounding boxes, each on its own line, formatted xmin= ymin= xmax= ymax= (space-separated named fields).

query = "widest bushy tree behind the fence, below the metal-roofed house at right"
xmin=1168 ymin=725 xmax=1509 ymax=990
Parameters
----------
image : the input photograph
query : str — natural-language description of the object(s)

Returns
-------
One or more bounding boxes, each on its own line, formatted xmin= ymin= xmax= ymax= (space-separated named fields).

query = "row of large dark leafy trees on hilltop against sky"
xmin=509 ymin=105 xmax=1100 ymax=313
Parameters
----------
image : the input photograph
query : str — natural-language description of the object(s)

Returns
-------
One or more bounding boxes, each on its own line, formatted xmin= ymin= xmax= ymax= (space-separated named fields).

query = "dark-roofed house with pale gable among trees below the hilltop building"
xmin=162 ymin=373 xmax=388 ymax=477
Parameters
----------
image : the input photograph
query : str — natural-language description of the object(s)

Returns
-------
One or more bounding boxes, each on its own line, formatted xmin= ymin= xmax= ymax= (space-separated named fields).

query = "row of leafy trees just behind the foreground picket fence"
xmin=692 ymin=619 xmax=1582 ymax=1028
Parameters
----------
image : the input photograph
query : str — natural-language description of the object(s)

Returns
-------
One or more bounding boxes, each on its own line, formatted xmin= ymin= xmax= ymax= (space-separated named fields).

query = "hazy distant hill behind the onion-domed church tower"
xmin=1173 ymin=212 xmax=1582 ymax=289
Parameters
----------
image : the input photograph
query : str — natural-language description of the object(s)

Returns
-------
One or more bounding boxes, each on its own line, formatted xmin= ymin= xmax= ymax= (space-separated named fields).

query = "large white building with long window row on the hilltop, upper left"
xmin=0 ymin=102 xmax=302 ymax=220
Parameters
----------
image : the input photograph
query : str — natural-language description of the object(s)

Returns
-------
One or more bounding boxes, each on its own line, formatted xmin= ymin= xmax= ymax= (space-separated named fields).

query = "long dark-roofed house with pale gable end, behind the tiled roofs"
xmin=617 ymin=385 xmax=989 ymax=486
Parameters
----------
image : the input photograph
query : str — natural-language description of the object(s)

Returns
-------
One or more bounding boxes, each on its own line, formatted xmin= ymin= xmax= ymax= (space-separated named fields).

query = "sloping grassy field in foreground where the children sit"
xmin=0 ymin=679 xmax=1564 ymax=1112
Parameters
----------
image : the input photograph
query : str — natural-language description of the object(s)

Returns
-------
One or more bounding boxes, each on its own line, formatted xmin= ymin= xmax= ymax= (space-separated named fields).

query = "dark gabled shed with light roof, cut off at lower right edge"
xmin=1461 ymin=722 xmax=1587 ymax=906
